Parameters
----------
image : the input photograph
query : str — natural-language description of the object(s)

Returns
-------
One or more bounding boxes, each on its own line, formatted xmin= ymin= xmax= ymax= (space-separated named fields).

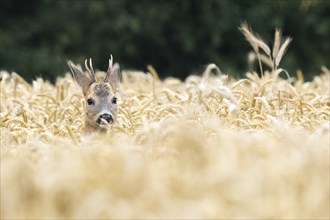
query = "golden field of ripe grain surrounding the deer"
xmin=0 ymin=65 xmax=330 ymax=219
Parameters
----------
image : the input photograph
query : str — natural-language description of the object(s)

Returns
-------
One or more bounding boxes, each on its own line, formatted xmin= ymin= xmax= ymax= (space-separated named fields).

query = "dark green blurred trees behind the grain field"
xmin=0 ymin=0 xmax=330 ymax=80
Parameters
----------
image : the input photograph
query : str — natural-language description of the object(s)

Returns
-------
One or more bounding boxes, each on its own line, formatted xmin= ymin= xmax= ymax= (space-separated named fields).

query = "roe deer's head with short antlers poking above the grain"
xmin=68 ymin=55 xmax=120 ymax=133
